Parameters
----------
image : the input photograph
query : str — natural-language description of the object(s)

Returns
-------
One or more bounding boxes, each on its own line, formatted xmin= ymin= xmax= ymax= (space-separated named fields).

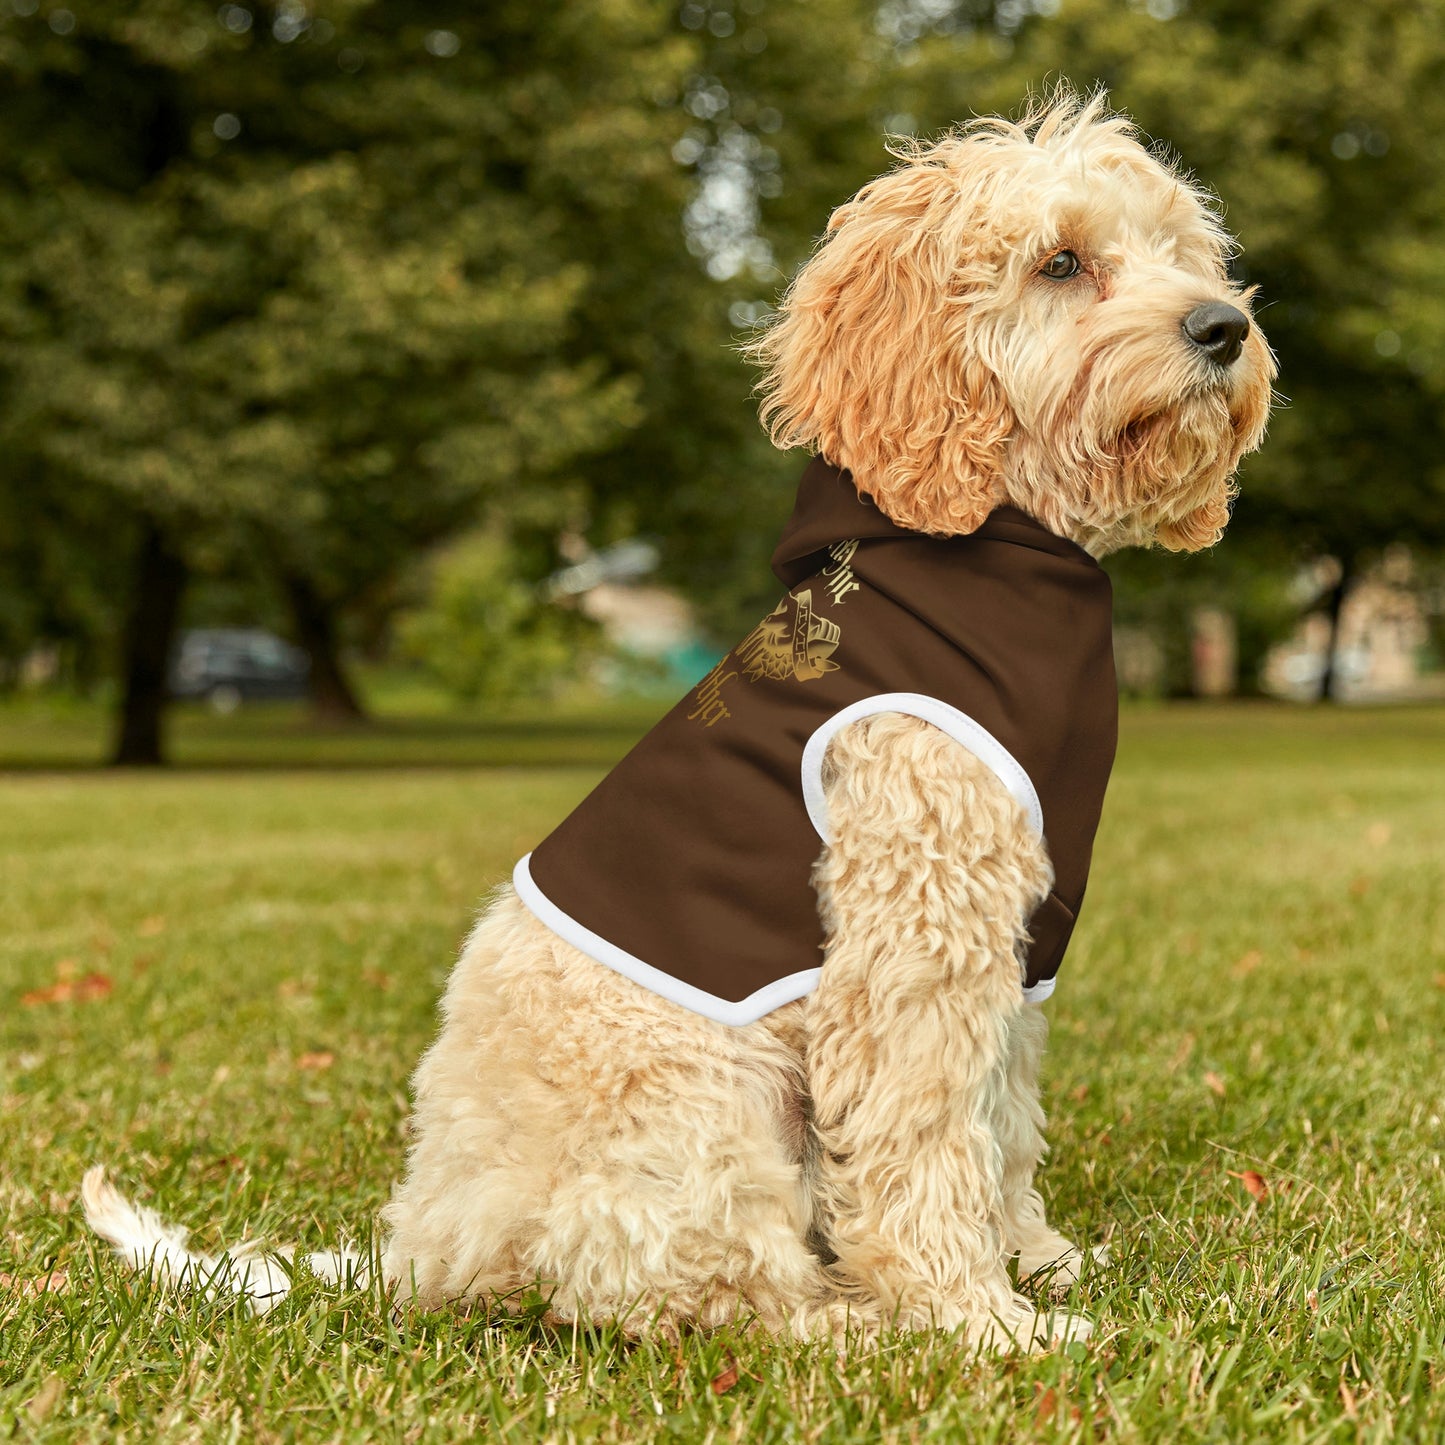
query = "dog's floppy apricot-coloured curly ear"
xmin=747 ymin=149 xmax=1013 ymax=533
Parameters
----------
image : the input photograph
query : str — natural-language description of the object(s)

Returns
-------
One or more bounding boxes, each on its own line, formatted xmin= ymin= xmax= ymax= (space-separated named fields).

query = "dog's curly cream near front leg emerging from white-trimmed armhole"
xmin=808 ymin=714 xmax=1088 ymax=1345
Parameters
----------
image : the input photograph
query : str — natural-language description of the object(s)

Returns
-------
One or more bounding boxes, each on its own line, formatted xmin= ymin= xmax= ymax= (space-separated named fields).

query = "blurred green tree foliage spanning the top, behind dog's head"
xmin=0 ymin=0 xmax=1445 ymax=699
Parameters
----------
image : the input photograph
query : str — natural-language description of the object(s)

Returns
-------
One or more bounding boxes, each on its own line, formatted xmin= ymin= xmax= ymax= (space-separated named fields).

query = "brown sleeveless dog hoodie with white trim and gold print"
xmin=513 ymin=458 xmax=1118 ymax=1025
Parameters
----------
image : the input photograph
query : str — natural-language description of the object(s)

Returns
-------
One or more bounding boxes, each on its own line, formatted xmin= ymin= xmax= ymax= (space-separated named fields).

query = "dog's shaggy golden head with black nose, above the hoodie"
xmin=750 ymin=91 xmax=1274 ymax=553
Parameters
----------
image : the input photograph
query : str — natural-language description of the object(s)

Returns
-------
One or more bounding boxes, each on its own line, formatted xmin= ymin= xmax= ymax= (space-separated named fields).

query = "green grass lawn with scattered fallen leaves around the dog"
xmin=0 ymin=708 xmax=1445 ymax=1442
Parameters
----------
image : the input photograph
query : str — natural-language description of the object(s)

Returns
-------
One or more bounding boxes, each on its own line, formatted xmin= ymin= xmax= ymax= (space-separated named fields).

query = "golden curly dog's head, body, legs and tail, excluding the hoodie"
xmin=84 ymin=92 xmax=1274 ymax=1347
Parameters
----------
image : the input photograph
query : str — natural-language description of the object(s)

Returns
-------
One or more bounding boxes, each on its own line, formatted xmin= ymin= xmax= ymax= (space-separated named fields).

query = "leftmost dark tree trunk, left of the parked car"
xmin=111 ymin=522 xmax=186 ymax=767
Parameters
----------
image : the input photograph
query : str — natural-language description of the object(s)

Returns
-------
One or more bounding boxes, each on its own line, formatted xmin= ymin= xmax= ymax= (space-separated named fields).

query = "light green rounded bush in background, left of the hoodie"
xmin=397 ymin=532 xmax=597 ymax=702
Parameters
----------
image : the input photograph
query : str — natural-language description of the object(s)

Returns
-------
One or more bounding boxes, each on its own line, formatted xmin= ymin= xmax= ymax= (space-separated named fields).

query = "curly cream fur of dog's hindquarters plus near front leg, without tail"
xmin=383 ymin=714 xmax=1084 ymax=1345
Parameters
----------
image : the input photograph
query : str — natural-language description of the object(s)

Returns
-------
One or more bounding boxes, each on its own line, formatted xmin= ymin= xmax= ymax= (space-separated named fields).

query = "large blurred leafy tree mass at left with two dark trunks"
xmin=0 ymin=0 xmax=691 ymax=763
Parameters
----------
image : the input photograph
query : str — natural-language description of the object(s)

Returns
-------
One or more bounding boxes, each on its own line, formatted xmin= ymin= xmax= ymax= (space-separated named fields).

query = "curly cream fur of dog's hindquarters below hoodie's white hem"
xmin=384 ymin=887 xmax=822 ymax=1332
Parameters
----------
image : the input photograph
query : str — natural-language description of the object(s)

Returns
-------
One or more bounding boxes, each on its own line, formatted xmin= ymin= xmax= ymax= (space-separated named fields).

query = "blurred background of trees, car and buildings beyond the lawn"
xmin=0 ymin=0 xmax=1445 ymax=764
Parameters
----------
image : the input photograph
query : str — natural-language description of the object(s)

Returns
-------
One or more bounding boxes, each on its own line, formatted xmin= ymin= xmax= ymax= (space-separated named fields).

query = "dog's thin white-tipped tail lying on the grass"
xmin=81 ymin=1165 xmax=368 ymax=1315
